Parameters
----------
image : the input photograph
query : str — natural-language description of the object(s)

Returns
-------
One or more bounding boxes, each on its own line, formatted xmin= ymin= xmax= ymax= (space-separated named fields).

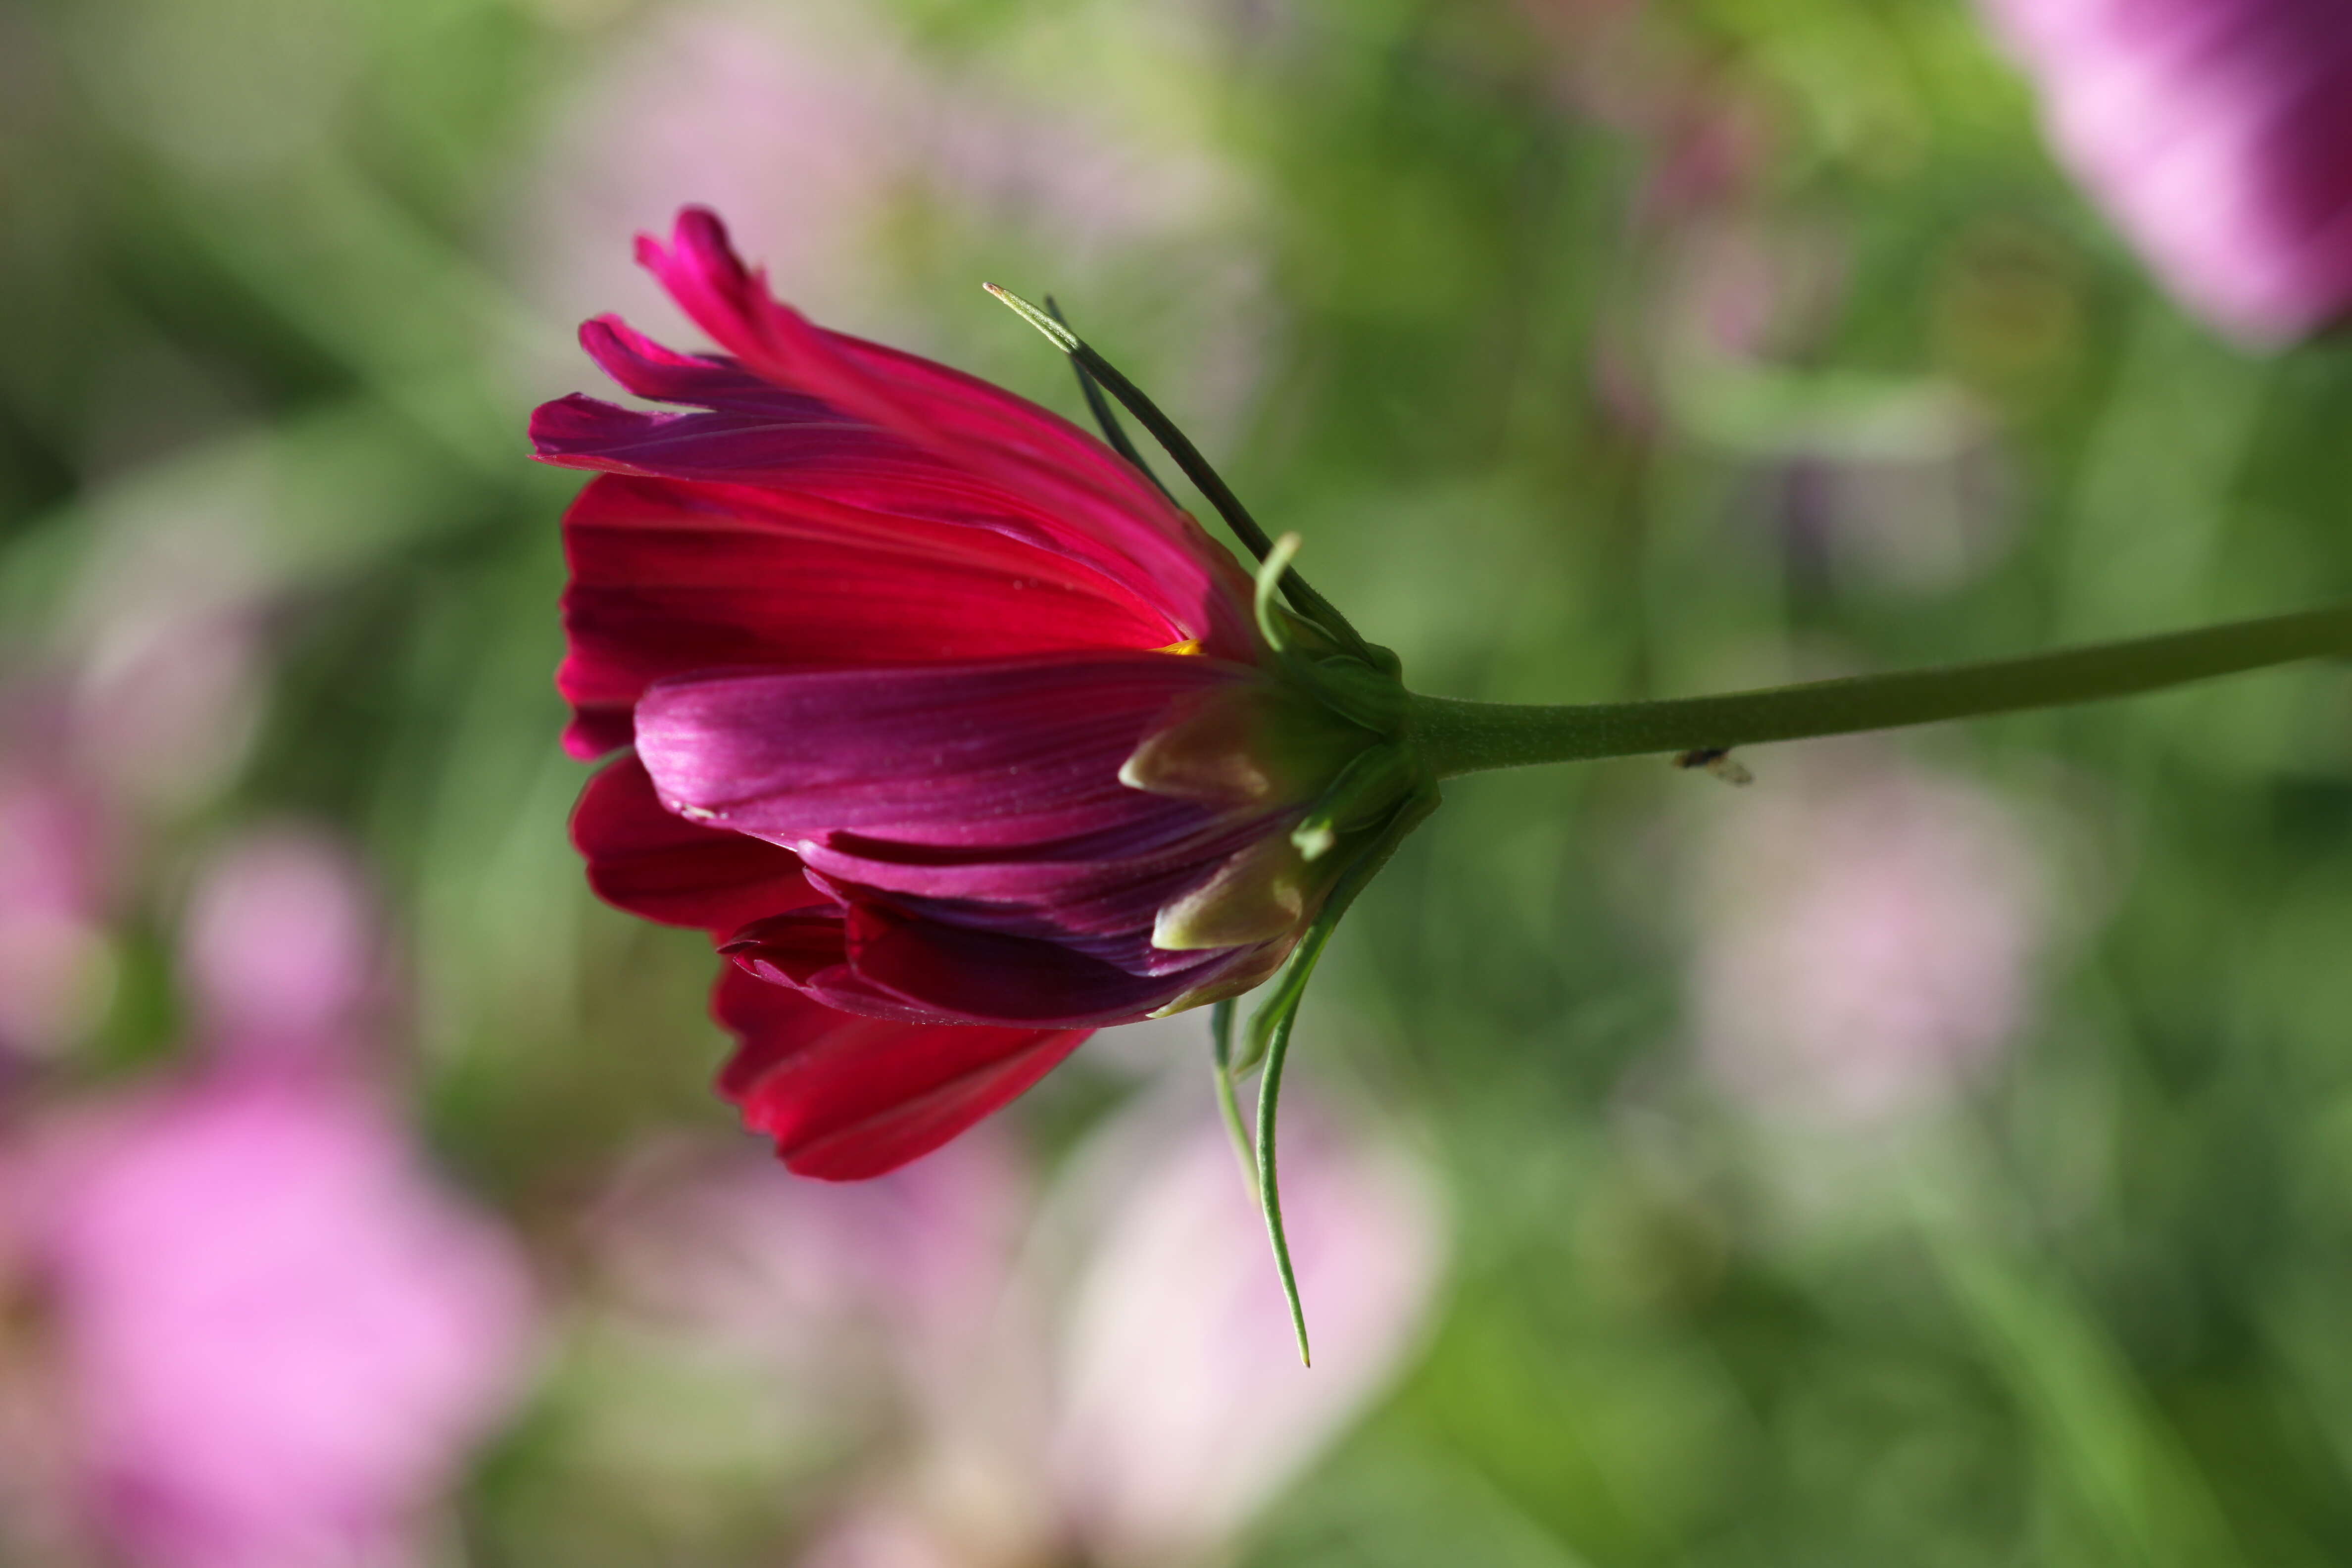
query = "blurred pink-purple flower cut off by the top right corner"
xmin=1983 ymin=0 xmax=2352 ymax=343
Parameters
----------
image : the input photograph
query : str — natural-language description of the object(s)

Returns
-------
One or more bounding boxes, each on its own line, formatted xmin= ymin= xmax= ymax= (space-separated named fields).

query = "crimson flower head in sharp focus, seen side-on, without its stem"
xmin=532 ymin=209 xmax=1395 ymax=1178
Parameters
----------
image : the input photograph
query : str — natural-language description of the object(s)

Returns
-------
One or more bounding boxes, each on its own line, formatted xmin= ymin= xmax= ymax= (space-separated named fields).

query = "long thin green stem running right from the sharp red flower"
xmin=1411 ymin=604 xmax=2352 ymax=778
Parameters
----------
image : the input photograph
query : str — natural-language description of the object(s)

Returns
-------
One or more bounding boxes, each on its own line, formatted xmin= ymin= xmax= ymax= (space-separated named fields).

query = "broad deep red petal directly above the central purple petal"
xmin=555 ymin=475 xmax=1167 ymax=757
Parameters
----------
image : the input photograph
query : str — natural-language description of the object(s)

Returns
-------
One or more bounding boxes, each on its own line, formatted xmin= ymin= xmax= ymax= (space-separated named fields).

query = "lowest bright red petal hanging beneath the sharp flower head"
xmin=710 ymin=966 xmax=1089 ymax=1182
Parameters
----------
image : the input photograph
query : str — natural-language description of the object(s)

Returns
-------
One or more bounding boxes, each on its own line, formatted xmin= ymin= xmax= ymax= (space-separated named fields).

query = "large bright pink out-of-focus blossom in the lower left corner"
xmin=35 ymin=1067 xmax=525 ymax=1568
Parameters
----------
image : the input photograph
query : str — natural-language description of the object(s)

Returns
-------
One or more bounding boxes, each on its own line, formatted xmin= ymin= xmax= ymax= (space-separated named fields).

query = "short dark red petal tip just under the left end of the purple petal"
xmin=572 ymin=757 xmax=823 ymax=931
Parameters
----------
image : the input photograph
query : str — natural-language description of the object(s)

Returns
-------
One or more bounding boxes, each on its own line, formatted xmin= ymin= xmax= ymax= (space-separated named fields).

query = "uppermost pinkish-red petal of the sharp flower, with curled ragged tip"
xmin=637 ymin=207 xmax=1251 ymax=656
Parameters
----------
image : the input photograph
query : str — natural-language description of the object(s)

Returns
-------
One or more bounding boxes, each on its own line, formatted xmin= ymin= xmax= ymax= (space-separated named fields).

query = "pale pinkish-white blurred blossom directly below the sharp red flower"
xmin=1051 ymin=1103 xmax=1444 ymax=1564
